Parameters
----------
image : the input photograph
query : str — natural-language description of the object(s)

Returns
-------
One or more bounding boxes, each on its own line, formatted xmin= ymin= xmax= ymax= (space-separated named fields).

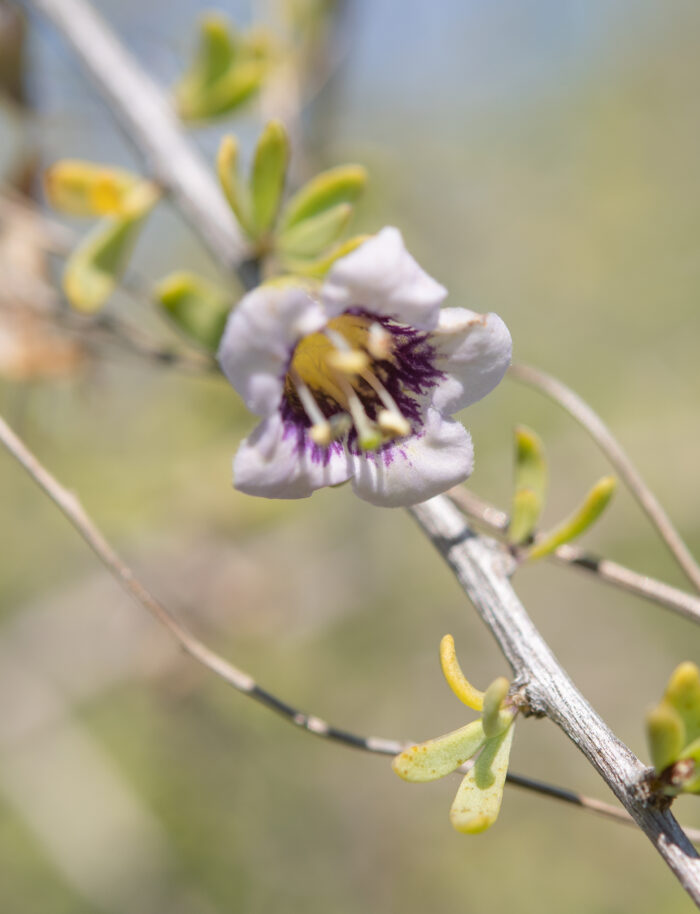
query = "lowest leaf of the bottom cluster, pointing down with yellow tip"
xmin=450 ymin=726 xmax=515 ymax=835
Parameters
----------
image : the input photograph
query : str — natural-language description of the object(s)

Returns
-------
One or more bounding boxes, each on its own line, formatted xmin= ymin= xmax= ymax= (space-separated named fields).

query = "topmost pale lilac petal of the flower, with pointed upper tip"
xmin=321 ymin=227 xmax=447 ymax=330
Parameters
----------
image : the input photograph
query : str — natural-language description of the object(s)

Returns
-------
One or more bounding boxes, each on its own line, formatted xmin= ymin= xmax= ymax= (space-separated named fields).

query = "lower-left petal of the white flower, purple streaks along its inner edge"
xmin=233 ymin=415 xmax=352 ymax=498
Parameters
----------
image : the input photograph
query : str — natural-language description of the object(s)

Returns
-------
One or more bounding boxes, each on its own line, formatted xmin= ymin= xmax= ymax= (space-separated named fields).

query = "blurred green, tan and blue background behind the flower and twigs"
xmin=0 ymin=0 xmax=700 ymax=914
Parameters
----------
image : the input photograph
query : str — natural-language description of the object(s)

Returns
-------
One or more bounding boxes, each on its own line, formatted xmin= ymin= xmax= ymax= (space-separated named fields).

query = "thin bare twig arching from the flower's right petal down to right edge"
xmin=508 ymin=364 xmax=700 ymax=591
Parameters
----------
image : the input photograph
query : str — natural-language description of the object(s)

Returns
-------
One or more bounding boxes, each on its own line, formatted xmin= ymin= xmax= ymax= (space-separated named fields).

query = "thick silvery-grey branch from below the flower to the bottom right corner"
xmin=410 ymin=495 xmax=700 ymax=907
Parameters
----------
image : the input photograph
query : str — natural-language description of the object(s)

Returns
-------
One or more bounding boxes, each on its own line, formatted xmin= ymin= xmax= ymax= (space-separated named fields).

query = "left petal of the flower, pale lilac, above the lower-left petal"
xmin=218 ymin=285 xmax=326 ymax=416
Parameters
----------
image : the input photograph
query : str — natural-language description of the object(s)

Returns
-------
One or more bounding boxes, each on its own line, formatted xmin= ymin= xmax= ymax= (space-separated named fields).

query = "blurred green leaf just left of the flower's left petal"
xmin=154 ymin=272 xmax=231 ymax=351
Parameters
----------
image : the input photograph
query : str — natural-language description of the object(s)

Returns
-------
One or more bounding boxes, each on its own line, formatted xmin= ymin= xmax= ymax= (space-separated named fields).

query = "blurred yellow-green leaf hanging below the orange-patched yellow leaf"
xmin=63 ymin=183 xmax=158 ymax=313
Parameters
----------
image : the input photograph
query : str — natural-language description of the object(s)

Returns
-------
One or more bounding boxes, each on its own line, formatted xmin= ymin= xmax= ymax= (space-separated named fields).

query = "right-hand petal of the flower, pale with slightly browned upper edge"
xmin=430 ymin=308 xmax=513 ymax=414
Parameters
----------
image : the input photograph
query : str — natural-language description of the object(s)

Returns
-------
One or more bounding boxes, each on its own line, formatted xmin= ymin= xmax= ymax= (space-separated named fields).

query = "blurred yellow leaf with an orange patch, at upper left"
xmin=44 ymin=159 xmax=142 ymax=216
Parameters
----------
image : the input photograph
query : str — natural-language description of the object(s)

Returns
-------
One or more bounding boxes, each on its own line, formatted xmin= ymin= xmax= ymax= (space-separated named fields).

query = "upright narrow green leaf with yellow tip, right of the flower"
xmin=508 ymin=426 xmax=547 ymax=544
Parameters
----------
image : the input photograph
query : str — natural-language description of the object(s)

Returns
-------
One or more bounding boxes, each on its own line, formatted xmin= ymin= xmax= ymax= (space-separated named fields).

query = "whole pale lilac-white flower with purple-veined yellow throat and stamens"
xmin=219 ymin=228 xmax=511 ymax=506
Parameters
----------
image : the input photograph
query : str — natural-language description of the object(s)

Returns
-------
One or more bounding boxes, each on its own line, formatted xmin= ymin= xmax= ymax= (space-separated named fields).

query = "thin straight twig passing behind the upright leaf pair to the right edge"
xmin=448 ymin=486 xmax=700 ymax=622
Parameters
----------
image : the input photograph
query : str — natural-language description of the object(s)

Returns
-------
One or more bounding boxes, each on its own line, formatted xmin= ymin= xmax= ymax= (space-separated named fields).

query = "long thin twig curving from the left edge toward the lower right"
xmin=0 ymin=410 xmax=700 ymax=841
